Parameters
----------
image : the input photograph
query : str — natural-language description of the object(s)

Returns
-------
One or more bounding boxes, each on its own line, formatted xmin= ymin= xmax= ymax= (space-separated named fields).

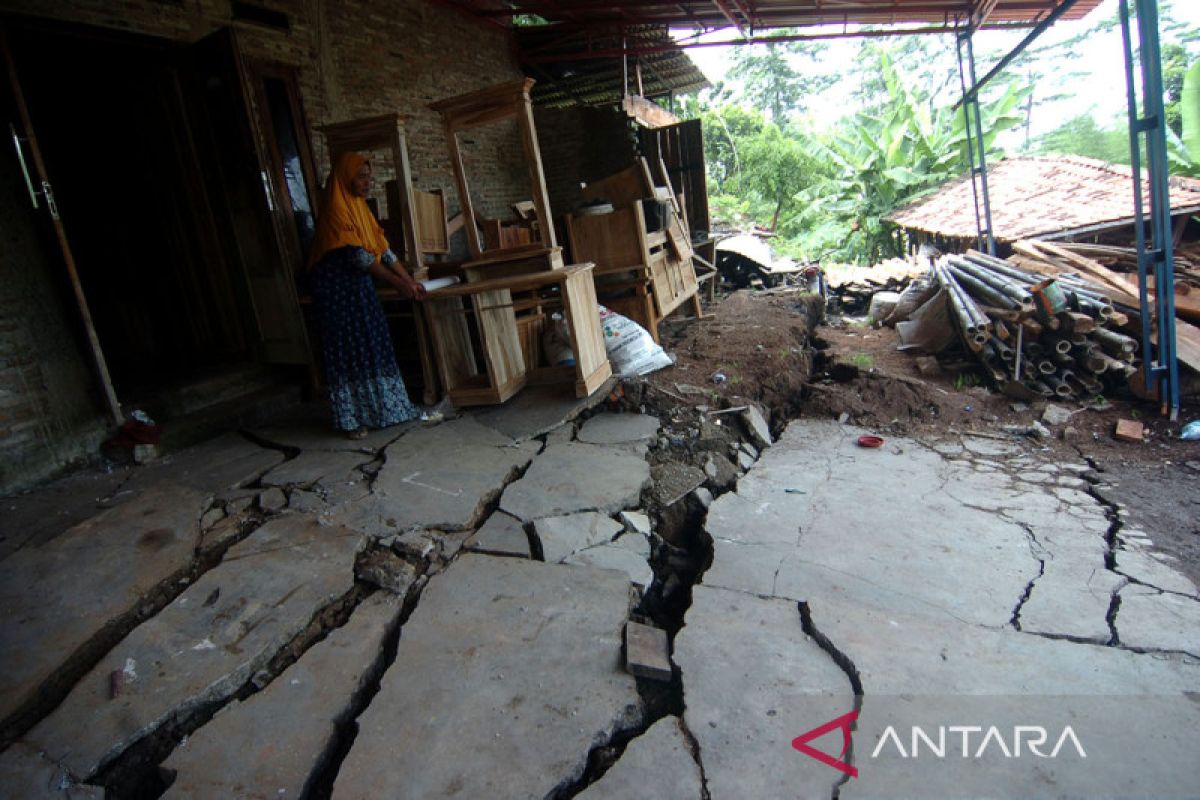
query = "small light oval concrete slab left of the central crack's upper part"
xmin=500 ymin=443 xmax=650 ymax=522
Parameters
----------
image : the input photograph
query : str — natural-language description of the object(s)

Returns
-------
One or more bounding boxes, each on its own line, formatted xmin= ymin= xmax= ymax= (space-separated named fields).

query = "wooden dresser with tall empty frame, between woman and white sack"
xmin=425 ymin=79 xmax=612 ymax=405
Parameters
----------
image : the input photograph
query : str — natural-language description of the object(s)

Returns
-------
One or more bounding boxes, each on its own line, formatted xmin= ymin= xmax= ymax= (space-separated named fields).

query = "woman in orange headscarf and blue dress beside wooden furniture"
xmin=308 ymin=152 xmax=425 ymax=439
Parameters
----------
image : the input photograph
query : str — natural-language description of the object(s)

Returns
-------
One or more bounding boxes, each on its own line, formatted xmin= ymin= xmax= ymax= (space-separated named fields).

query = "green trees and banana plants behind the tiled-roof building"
xmin=683 ymin=1 xmax=1200 ymax=264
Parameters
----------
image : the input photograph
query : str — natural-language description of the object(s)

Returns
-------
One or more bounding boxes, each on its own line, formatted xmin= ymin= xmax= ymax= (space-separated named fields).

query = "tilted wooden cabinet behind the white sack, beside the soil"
xmin=566 ymin=160 xmax=701 ymax=342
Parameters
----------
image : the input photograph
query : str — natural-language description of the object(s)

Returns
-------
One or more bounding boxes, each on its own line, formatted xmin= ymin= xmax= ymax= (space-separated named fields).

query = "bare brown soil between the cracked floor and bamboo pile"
xmin=648 ymin=290 xmax=1200 ymax=584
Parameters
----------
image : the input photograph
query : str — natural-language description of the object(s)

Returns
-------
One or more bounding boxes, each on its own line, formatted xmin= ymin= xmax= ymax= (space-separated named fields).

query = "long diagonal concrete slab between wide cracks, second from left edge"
xmin=24 ymin=516 xmax=362 ymax=780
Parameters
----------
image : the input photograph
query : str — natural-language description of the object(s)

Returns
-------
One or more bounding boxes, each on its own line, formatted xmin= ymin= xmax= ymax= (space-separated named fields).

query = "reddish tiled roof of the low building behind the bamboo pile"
xmin=887 ymin=156 xmax=1200 ymax=241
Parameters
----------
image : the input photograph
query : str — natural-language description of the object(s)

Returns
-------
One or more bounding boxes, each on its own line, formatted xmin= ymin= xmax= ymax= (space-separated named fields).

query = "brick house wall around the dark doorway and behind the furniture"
xmin=0 ymin=0 xmax=528 ymax=493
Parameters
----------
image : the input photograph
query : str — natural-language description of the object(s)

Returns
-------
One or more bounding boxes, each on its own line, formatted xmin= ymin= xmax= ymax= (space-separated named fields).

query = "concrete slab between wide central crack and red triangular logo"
xmin=674 ymin=587 xmax=854 ymax=800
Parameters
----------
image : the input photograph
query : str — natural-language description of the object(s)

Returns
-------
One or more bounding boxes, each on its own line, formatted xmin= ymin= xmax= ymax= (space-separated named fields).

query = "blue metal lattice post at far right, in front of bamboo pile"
xmin=1121 ymin=0 xmax=1180 ymax=420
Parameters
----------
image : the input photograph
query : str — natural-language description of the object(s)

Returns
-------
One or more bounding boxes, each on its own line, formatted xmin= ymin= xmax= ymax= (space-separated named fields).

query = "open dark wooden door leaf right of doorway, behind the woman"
xmin=181 ymin=29 xmax=310 ymax=363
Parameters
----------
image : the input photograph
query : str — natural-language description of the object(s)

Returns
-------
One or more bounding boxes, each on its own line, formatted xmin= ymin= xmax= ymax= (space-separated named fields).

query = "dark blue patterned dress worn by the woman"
xmin=310 ymin=247 xmax=419 ymax=431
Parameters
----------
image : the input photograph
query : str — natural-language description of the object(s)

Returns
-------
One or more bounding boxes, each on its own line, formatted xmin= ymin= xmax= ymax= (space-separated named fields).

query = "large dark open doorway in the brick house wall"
xmin=5 ymin=19 xmax=307 ymax=403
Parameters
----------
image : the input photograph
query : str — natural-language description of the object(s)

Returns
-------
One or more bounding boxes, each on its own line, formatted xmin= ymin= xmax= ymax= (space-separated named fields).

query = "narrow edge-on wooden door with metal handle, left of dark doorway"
xmin=0 ymin=25 xmax=125 ymax=425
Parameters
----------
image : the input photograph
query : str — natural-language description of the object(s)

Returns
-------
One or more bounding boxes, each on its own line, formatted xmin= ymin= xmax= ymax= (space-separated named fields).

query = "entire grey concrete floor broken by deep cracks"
xmin=0 ymin=395 xmax=1200 ymax=800
